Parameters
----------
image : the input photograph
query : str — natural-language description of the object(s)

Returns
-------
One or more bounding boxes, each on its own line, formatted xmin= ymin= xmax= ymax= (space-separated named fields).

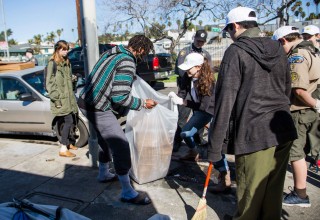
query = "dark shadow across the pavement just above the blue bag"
xmin=0 ymin=164 xmax=157 ymax=220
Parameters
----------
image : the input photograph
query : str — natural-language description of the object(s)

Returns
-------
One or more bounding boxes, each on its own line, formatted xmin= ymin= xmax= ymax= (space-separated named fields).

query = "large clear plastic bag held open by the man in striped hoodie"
xmin=125 ymin=77 xmax=178 ymax=184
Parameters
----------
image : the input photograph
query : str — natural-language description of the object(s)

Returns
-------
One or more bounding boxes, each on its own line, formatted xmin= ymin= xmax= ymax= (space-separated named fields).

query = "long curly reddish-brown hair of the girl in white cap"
xmin=197 ymin=58 xmax=215 ymax=96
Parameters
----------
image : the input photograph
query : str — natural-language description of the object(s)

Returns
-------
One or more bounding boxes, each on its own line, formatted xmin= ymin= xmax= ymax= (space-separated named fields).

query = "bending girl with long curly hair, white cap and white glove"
xmin=168 ymin=53 xmax=215 ymax=161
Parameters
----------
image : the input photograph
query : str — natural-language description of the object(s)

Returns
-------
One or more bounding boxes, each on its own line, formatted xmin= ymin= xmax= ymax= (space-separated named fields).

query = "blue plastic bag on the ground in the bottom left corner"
xmin=0 ymin=199 xmax=90 ymax=220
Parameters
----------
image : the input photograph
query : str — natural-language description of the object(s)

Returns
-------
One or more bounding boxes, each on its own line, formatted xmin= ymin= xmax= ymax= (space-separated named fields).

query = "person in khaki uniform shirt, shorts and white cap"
xmin=273 ymin=26 xmax=320 ymax=207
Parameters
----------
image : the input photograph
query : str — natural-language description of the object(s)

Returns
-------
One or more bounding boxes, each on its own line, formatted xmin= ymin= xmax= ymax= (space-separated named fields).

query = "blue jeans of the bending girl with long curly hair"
xmin=180 ymin=111 xmax=212 ymax=149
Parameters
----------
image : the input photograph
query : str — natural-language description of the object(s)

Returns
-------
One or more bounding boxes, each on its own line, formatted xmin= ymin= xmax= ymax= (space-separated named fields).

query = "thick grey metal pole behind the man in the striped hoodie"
xmin=80 ymin=0 xmax=99 ymax=167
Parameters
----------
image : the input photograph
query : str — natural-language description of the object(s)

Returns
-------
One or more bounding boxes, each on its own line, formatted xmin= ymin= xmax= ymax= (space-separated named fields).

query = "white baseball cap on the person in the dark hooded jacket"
xmin=223 ymin=7 xmax=257 ymax=30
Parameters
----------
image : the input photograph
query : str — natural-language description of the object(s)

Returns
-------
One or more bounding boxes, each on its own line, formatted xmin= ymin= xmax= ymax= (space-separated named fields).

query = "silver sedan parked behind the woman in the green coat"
xmin=0 ymin=66 xmax=89 ymax=147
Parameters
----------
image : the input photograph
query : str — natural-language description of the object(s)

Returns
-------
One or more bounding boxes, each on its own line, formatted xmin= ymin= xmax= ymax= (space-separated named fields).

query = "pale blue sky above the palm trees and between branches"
xmin=0 ymin=0 xmax=315 ymax=42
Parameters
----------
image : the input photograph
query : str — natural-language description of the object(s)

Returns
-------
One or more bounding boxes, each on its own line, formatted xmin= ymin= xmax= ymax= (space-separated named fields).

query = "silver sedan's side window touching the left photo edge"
xmin=0 ymin=77 xmax=28 ymax=100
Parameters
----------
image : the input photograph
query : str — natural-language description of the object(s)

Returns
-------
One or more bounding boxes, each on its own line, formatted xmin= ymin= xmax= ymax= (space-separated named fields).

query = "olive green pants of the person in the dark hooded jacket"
xmin=234 ymin=142 xmax=292 ymax=220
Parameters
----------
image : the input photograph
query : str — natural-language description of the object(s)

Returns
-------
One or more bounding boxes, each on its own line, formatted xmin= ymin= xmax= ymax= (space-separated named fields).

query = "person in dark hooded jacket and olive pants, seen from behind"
xmin=208 ymin=7 xmax=297 ymax=220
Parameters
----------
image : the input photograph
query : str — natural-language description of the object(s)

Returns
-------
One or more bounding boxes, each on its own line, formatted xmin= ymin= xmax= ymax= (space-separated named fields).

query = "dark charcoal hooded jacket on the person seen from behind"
xmin=208 ymin=28 xmax=297 ymax=162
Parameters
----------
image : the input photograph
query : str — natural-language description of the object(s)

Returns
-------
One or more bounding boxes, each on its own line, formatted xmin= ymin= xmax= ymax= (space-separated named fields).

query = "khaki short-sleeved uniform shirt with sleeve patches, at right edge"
xmin=288 ymin=41 xmax=320 ymax=111
